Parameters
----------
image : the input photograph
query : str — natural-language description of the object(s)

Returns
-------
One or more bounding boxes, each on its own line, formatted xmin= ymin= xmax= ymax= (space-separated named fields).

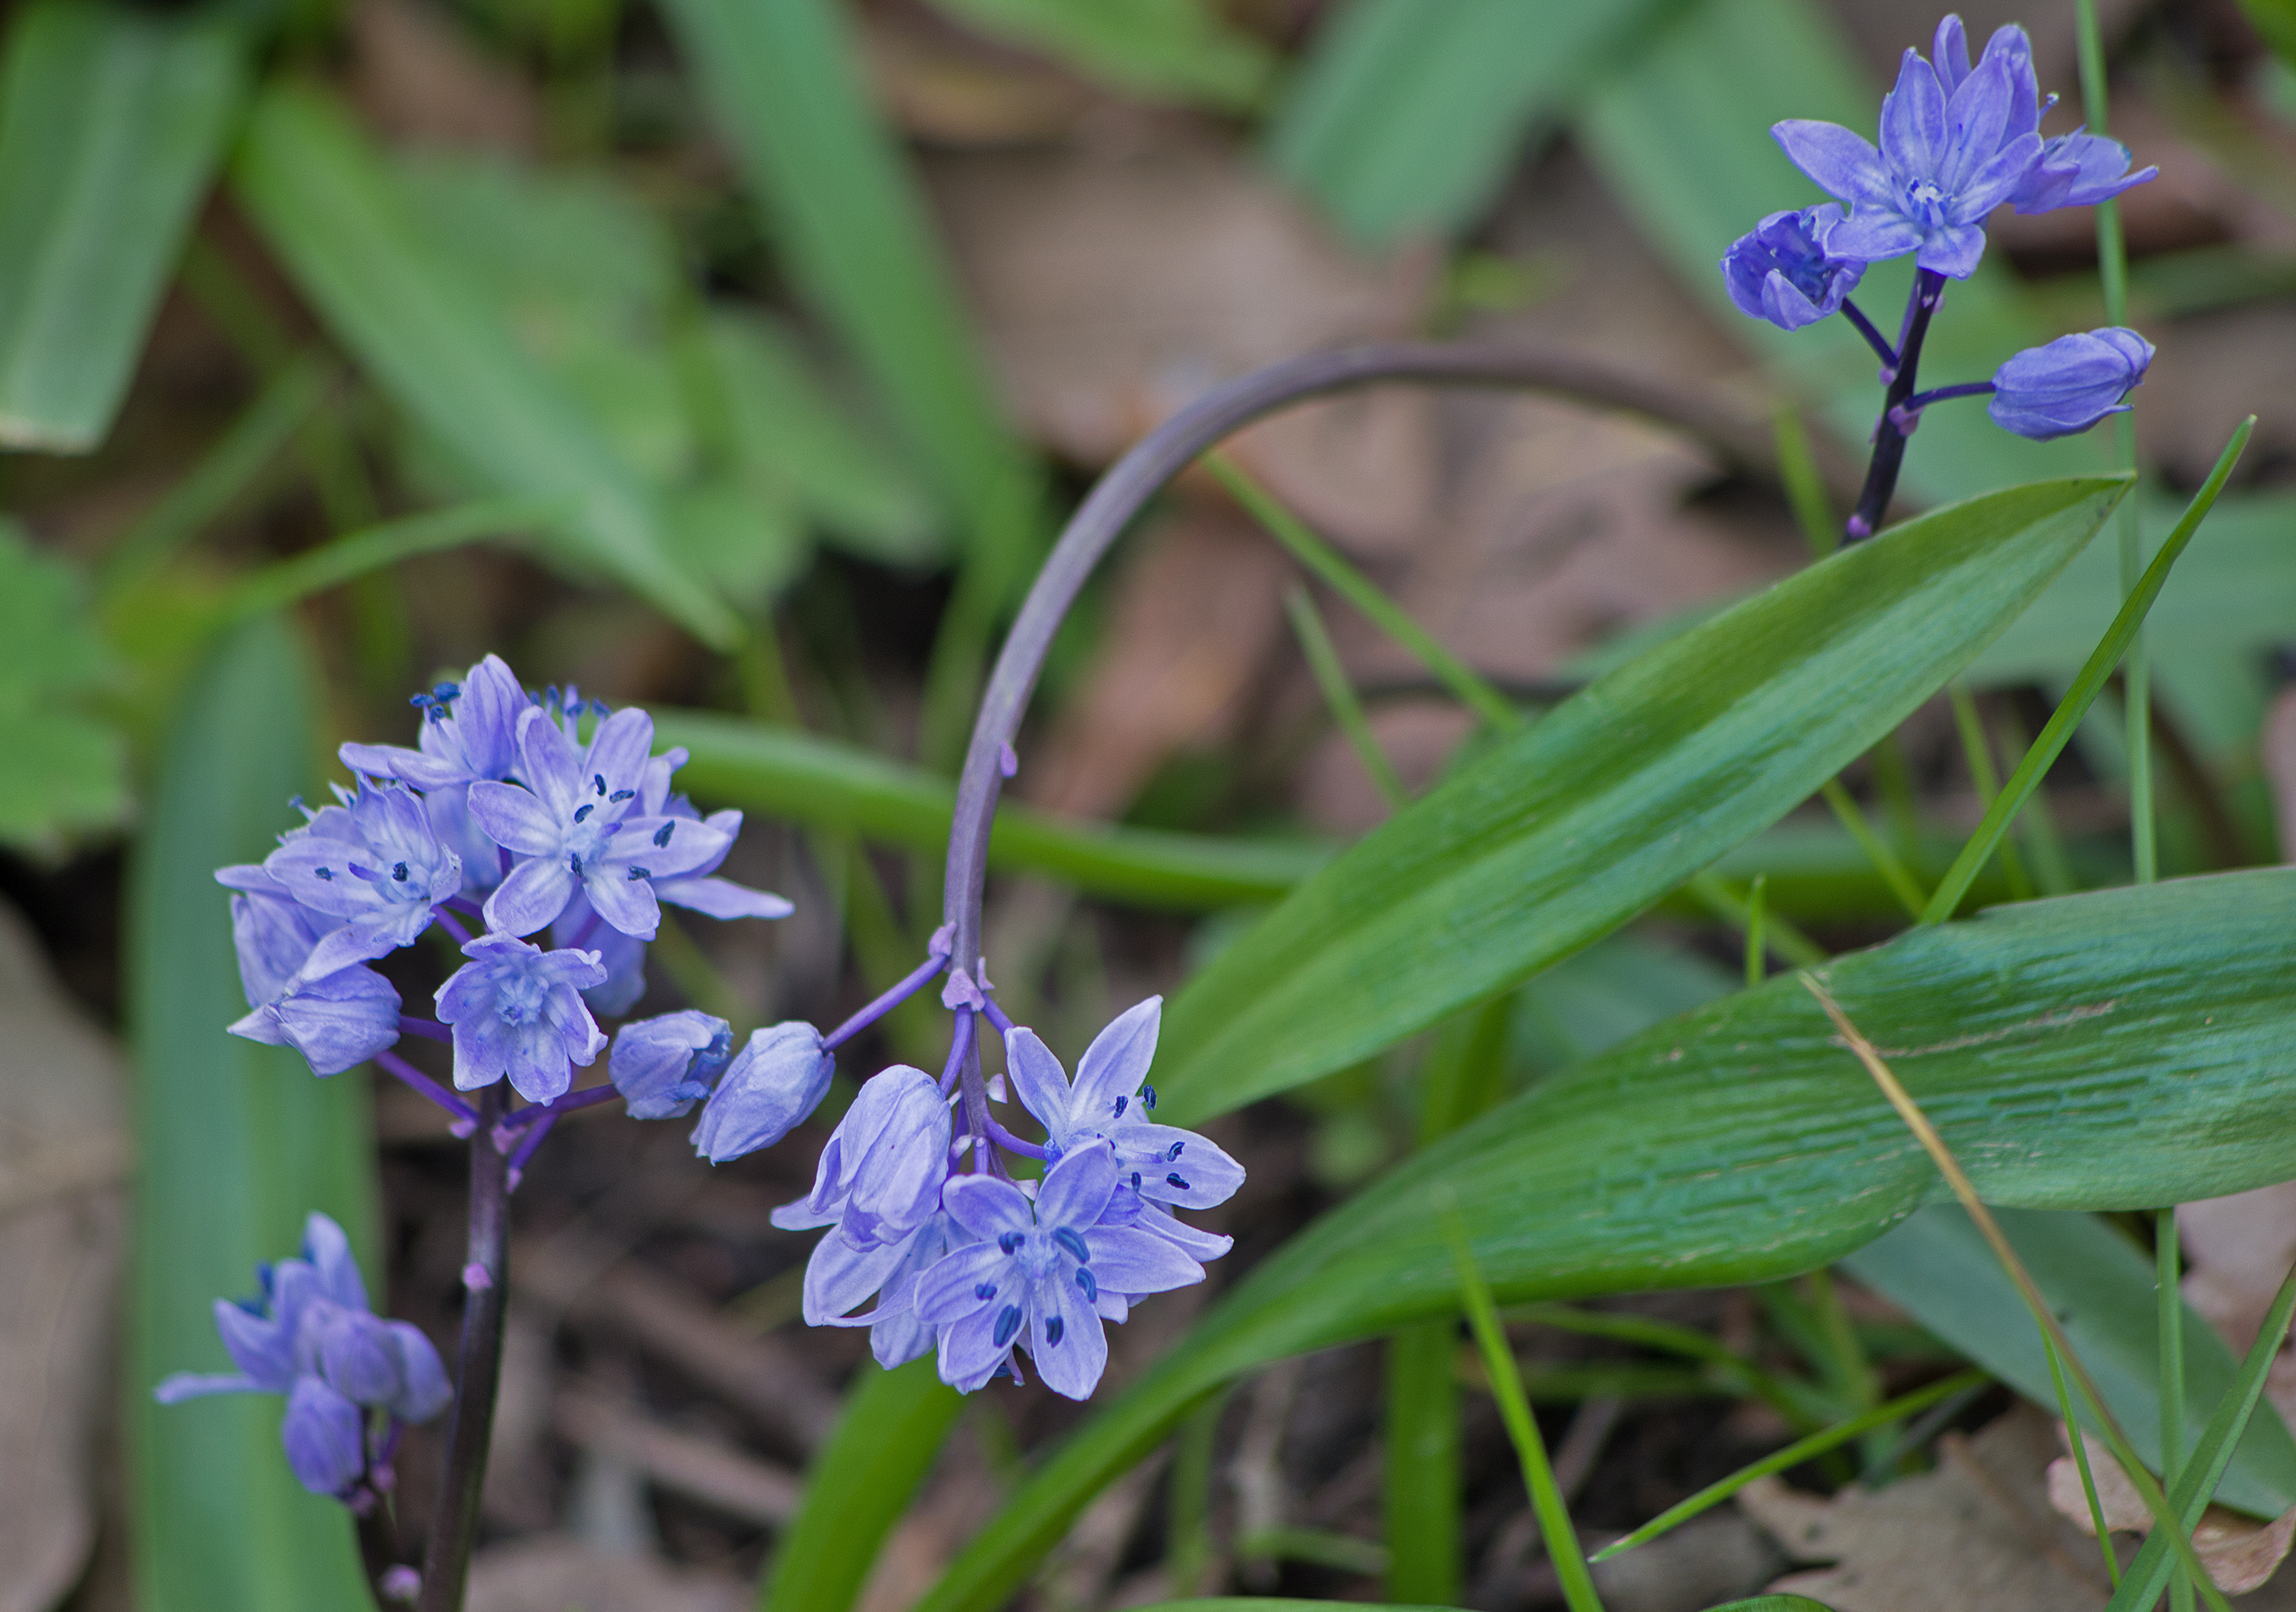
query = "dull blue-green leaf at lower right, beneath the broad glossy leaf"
xmin=1843 ymin=1203 xmax=2296 ymax=1518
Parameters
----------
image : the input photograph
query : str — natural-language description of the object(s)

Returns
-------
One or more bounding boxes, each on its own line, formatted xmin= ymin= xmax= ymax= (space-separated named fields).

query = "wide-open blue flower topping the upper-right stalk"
xmin=1770 ymin=18 xmax=2041 ymax=280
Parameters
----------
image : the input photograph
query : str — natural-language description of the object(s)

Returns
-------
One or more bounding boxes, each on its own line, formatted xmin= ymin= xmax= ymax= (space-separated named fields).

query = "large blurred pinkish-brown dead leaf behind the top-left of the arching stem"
xmin=932 ymin=132 xmax=1435 ymax=551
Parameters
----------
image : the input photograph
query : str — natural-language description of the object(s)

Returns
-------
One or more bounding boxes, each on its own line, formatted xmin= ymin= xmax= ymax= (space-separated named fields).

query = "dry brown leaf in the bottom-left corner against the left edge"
xmin=0 ymin=907 xmax=126 ymax=1612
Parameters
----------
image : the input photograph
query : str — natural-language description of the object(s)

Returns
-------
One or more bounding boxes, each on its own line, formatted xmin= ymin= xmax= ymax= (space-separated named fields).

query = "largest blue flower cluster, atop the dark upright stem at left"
xmin=216 ymin=654 xmax=790 ymax=1164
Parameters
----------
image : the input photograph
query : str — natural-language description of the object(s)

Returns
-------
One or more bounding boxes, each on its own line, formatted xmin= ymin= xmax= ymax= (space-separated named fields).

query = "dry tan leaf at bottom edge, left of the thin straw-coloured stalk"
xmin=1738 ymin=1408 xmax=2107 ymax=1612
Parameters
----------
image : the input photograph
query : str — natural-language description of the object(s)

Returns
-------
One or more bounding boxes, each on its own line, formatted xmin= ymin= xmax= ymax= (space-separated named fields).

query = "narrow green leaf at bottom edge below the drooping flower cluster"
xmin=758 ymin=1355 xmax=964 ymax=1612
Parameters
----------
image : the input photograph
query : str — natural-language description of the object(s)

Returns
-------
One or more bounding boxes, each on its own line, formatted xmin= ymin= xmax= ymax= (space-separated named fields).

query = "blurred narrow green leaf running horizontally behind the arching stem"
xmin=654 ymin=709 xmax=1327 ymax=909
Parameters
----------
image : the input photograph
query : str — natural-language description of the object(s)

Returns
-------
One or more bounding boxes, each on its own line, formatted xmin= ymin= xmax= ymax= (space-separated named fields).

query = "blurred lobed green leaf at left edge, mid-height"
xmin=0 ymin=519 xmax=129 ymax=845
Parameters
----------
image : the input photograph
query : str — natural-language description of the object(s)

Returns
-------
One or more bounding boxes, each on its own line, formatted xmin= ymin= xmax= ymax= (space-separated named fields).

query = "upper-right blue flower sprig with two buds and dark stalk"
xmin=1722 ymin=16 xmax=2158 ymax=537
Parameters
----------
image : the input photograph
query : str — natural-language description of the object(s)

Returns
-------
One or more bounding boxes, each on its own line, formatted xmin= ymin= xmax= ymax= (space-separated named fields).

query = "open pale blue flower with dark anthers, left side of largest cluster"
xmin=264 ymin=778 xmax=462 ymax=976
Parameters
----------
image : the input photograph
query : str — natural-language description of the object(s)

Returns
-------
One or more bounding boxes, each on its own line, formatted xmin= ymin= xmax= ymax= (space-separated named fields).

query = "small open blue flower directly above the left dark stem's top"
xmin=439 ymin=935 xmax=606 ymax=1102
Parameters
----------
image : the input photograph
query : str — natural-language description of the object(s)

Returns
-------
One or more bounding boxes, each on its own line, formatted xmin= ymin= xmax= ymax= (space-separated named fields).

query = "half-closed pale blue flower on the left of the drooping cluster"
xmin=771 ymin=1063 xmax=950 ymax=1254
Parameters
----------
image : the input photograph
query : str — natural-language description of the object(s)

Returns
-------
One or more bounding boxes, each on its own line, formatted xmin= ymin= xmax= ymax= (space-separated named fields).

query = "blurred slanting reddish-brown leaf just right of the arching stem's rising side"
xmin=1019 ymin=512 xmax=1291 ymax=817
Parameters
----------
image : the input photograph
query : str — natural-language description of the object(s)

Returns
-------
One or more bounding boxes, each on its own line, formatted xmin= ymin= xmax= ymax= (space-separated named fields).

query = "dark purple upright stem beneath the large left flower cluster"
xmin=416 ymin=1084 xmax=510 ymax=1612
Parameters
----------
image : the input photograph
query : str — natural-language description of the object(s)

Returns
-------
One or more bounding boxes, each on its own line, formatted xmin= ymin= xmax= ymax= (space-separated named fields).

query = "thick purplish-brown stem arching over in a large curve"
xmin=944 ymin=342 xmax=1846 ymax=972
